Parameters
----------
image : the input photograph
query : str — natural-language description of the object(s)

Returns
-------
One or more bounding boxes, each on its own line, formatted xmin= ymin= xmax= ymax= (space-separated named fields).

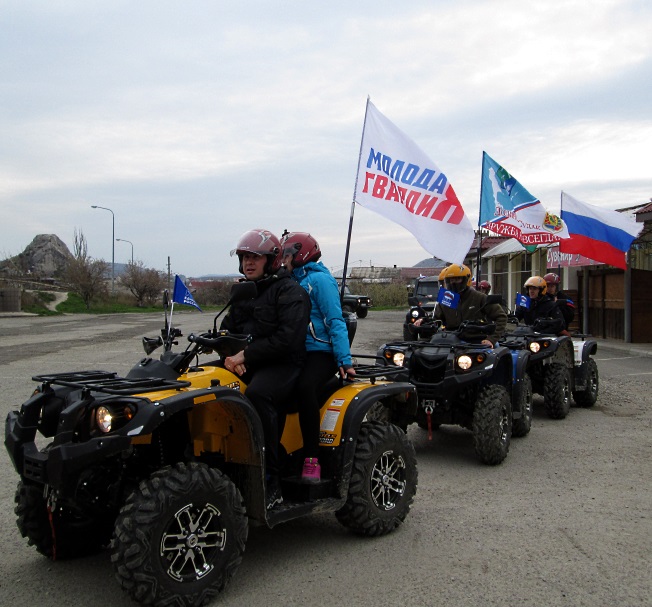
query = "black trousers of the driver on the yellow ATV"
xmin=242 ymin=363 xmax=301 ymax=476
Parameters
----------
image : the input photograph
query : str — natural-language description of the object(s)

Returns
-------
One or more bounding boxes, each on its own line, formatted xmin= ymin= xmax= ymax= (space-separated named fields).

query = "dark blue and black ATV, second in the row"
xmin=377 ymin=321 xmax=532 ymax=465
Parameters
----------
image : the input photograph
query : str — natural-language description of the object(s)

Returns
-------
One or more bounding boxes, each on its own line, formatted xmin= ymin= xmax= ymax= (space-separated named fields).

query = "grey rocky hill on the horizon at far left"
xmin=0 ymin=234 xmax=72 ymax=278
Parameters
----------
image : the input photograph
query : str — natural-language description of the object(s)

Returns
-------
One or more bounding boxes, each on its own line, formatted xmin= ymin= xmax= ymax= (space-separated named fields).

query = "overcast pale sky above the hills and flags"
xmin=0 ymin=0 xmax=652 ymax=276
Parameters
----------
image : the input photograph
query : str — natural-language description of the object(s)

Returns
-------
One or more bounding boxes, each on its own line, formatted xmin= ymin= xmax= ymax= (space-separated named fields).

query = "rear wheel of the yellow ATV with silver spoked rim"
xmin=336 ymin=421 xmax=417 ymax=536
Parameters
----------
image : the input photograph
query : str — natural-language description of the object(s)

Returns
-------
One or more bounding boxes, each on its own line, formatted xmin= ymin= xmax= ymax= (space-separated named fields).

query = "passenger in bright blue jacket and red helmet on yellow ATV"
xmin=281 ymin=232 xmax=355 ymax=483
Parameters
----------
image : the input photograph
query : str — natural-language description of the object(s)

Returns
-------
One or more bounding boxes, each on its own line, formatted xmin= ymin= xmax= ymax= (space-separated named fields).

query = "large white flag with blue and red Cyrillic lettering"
xmin=354 ymin=101 xmax=474 ymax=263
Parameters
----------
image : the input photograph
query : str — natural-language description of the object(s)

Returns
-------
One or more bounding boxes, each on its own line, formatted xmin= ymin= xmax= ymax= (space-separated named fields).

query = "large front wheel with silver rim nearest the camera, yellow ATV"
xmin=111 ymin=463 xmax=248 ymax=607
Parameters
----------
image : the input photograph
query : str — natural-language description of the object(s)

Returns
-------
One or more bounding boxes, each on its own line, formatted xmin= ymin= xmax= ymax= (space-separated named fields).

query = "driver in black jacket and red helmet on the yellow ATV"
xmin=221 ymin=229 xmax=310 ymax=508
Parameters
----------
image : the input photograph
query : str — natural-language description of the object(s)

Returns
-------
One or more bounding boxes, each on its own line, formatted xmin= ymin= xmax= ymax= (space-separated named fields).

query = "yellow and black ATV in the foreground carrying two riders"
xmin=5 ymin=283 xmax=417 ymax=607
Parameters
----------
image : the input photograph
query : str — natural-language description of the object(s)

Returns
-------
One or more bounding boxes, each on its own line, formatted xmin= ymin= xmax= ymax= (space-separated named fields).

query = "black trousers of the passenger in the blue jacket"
xmin=295 ymin=352 xmax=337 ymax=457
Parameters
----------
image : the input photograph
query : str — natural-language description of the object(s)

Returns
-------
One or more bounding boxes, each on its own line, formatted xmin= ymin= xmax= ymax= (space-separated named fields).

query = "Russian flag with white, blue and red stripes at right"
xmin=559 ymin=192 xmax=643 ymax=270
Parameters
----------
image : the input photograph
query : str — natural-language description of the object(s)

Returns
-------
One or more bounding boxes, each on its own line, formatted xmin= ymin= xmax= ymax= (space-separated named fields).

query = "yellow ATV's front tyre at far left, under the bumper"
xmin=14 ymin=481 xmax=111 ymax=560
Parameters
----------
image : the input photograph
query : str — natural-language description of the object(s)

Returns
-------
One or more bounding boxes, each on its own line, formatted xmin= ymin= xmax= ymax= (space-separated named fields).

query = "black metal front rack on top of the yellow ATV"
xmin=32 ymin=371 xmax=190 ymax=395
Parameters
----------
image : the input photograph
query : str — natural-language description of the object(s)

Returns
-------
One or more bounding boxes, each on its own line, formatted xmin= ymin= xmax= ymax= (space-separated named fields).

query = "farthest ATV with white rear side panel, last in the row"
xmin=501 ymin=319 xmax=599 ymax=419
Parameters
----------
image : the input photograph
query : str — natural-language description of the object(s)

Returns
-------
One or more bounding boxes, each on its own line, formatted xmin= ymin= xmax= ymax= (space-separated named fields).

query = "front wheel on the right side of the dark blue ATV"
xmin=471 ymin=385 xmax=512 ymax=466
